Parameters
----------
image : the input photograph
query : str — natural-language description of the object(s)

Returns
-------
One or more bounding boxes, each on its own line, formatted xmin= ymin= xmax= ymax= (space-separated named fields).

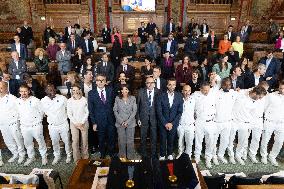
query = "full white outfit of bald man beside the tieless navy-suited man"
xmin=177 ymin=97 xmax=195 ymax=157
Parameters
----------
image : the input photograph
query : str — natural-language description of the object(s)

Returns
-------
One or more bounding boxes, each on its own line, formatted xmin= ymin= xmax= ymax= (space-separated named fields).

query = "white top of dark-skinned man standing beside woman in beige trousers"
xmin=41 ymin=94 xmax=67 ymax=126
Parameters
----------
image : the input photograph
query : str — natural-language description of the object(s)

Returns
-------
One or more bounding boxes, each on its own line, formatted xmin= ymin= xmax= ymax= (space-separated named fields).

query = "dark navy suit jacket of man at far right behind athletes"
xmin=259 ymin=57 xmax=281 ymax=86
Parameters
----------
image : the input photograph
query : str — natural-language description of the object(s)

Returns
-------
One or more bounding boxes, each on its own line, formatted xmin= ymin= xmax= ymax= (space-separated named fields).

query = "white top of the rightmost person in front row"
xmin=265 ymin=92 xmax=284 ymax=122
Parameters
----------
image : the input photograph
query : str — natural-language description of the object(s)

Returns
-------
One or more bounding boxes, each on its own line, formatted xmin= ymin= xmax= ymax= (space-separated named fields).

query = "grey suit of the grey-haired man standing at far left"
xmin=8 ymin=59 xmax=27 ymax=80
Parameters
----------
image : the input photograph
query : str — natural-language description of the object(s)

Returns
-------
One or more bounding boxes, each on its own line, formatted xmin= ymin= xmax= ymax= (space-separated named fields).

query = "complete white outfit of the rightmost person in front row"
xmin=260 ymin=92 xmax=284 ymax=159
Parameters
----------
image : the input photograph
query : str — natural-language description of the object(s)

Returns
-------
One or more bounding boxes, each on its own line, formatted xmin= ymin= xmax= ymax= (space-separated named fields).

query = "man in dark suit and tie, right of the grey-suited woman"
xmin=137 ymin=77 xmax=159 ymax=157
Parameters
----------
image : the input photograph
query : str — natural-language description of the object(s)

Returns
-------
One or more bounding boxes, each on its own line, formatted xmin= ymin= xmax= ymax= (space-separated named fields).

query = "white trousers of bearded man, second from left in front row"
xmin=21 ymin=123 xmax=47 ymax=158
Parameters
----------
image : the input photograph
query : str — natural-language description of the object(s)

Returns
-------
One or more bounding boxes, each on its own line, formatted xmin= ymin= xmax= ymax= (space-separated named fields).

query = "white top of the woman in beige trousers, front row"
xmin=67 ymin=96 xmax=89 ymax=124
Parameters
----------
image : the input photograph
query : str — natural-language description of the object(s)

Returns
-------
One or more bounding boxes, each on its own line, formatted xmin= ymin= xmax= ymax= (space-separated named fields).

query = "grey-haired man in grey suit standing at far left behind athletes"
xmin=8 ymin=51 xmax=27 ymax=80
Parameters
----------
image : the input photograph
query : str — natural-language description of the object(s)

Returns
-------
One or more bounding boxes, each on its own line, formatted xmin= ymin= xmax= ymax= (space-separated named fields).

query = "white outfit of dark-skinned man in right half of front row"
xmin=214 ymin=89 xmax=238 ymax=157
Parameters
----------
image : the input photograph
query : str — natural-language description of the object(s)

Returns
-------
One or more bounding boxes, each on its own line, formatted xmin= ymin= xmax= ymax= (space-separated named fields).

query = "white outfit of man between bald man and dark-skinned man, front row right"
xmin=193 ymin=89 xmax=217 ymax=161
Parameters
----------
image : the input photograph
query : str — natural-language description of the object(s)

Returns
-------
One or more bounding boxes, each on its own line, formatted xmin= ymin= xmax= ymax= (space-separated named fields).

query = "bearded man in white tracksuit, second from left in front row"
xmin=17 ymin=85 xmax=47 ymax=166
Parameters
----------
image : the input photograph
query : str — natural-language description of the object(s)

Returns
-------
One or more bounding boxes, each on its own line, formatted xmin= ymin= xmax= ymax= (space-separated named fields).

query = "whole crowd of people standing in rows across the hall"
xmin=0 ymin=19 xmax=284 ymax=168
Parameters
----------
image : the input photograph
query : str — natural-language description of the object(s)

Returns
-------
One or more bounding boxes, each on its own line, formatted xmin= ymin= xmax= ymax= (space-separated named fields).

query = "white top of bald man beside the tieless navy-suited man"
xmin=180 ymin=97 xmax=195 ymax=125
